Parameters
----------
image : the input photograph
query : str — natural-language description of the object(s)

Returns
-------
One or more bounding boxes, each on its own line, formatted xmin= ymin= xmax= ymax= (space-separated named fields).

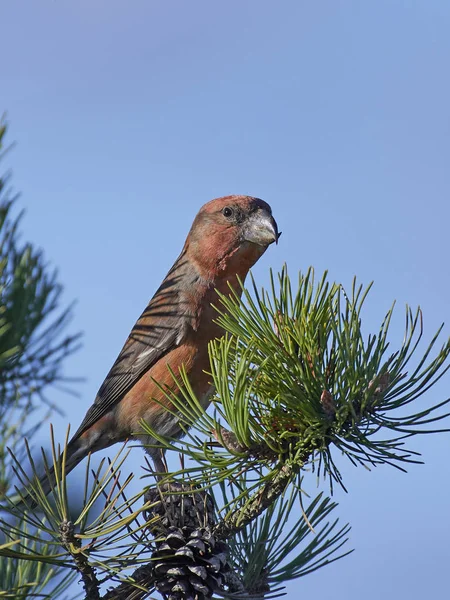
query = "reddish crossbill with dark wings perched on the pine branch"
xmin=21 ymin=195 xmax=281 ymax=504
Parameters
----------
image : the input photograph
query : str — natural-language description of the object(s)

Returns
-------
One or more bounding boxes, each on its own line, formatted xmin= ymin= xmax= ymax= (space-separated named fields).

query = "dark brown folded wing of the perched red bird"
xmin=73 ymin=253 xmax=193 ymax=439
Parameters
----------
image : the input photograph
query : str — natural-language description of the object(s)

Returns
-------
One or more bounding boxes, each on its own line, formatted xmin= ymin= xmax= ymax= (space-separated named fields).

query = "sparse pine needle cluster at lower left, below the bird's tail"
xmin=0 ymin=431 xmax=153 ymax=582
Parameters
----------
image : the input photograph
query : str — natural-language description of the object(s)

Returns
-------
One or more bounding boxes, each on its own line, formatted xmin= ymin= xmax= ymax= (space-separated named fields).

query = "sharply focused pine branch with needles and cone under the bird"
xmin=0 ymin=117 xmax=450 ymax=600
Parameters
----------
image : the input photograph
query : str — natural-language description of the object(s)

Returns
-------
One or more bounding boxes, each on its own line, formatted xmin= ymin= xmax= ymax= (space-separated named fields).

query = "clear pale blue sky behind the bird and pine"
xmin=0 ymin=0 xmax=450 ymax=600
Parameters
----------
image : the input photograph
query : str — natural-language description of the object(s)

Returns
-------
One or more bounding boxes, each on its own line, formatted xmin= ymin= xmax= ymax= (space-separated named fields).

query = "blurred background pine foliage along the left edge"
xmin=0 ymin=120 xmax=79 ymax=599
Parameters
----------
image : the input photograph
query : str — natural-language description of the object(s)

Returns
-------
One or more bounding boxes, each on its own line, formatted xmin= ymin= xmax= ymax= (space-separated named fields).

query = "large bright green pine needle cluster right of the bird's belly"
xmin=142 ymin=268 xmax=450 ymax=496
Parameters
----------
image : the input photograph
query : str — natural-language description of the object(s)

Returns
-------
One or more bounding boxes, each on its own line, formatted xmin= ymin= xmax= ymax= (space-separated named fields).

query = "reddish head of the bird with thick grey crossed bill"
xmin=185 ymin=196 xmax=280 ymax=279
